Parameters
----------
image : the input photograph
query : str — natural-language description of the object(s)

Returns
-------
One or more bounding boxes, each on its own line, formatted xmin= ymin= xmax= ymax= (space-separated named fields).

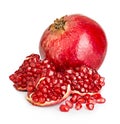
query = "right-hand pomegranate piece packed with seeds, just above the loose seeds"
xmin=65 ymin=65 xmax=105 ymax=93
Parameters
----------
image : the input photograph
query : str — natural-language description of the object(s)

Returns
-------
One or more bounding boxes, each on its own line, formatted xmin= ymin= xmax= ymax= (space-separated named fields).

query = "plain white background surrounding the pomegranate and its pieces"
xmin=0 ymin=0 xmax=120 ymax=124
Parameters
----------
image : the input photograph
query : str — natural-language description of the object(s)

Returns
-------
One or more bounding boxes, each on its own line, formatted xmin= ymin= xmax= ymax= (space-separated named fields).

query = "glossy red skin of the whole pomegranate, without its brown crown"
xmin=39 ymin=14 xmax=107 ymax=69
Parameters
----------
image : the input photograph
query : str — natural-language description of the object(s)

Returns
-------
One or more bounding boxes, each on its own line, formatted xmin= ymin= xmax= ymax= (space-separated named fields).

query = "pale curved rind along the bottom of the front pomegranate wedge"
xmin=26 ymin=84 xmax=71 ymax=107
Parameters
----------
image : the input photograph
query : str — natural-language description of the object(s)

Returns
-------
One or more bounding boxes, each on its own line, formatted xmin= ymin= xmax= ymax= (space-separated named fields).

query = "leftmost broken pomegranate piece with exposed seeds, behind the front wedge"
xmin=9 ymin=54 xmax=55 ymax=91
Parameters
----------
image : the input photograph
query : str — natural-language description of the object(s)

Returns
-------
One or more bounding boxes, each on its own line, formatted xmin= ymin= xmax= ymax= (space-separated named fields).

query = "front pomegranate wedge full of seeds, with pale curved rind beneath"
xmin=27 ymin=72 xmax=71 ymax=106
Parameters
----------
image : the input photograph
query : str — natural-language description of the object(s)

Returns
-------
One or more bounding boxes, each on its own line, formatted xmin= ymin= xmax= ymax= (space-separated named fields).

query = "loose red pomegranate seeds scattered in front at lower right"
xmin=59 ymin=93 xmax=106 ymax=112
